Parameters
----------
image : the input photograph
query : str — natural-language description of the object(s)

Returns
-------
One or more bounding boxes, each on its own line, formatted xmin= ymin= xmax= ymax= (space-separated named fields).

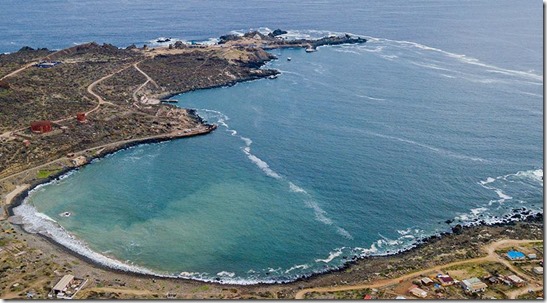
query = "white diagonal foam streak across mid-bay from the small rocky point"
xmin=198 ymin=109 xmax=353 ymax=240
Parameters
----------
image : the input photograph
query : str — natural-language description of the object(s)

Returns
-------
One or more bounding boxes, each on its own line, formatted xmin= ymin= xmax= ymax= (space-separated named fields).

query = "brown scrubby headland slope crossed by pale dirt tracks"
xmin=0 ymin=43 xmax=277 ymax=183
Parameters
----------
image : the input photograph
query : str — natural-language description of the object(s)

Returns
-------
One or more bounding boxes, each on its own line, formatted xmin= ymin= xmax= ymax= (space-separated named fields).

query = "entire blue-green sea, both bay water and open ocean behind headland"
xmin=4 ymin=0 xmax=543 ymax=283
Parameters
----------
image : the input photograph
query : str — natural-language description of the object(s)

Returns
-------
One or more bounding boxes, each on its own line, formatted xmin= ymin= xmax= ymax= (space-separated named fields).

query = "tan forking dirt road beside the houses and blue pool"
xmin=295 ymin=239 xmax=543 ymax=299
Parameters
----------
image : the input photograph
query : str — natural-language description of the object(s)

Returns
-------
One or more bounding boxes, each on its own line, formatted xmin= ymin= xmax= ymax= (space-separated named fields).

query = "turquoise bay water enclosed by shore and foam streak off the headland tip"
xmin=15 ymin=38 xmax=543 ymax=283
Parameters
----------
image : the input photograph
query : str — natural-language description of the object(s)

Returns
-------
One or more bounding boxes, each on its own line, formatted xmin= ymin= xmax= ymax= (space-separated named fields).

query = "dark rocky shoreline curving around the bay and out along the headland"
xmin=0 ymin=30 xmax=543 ymax=300
